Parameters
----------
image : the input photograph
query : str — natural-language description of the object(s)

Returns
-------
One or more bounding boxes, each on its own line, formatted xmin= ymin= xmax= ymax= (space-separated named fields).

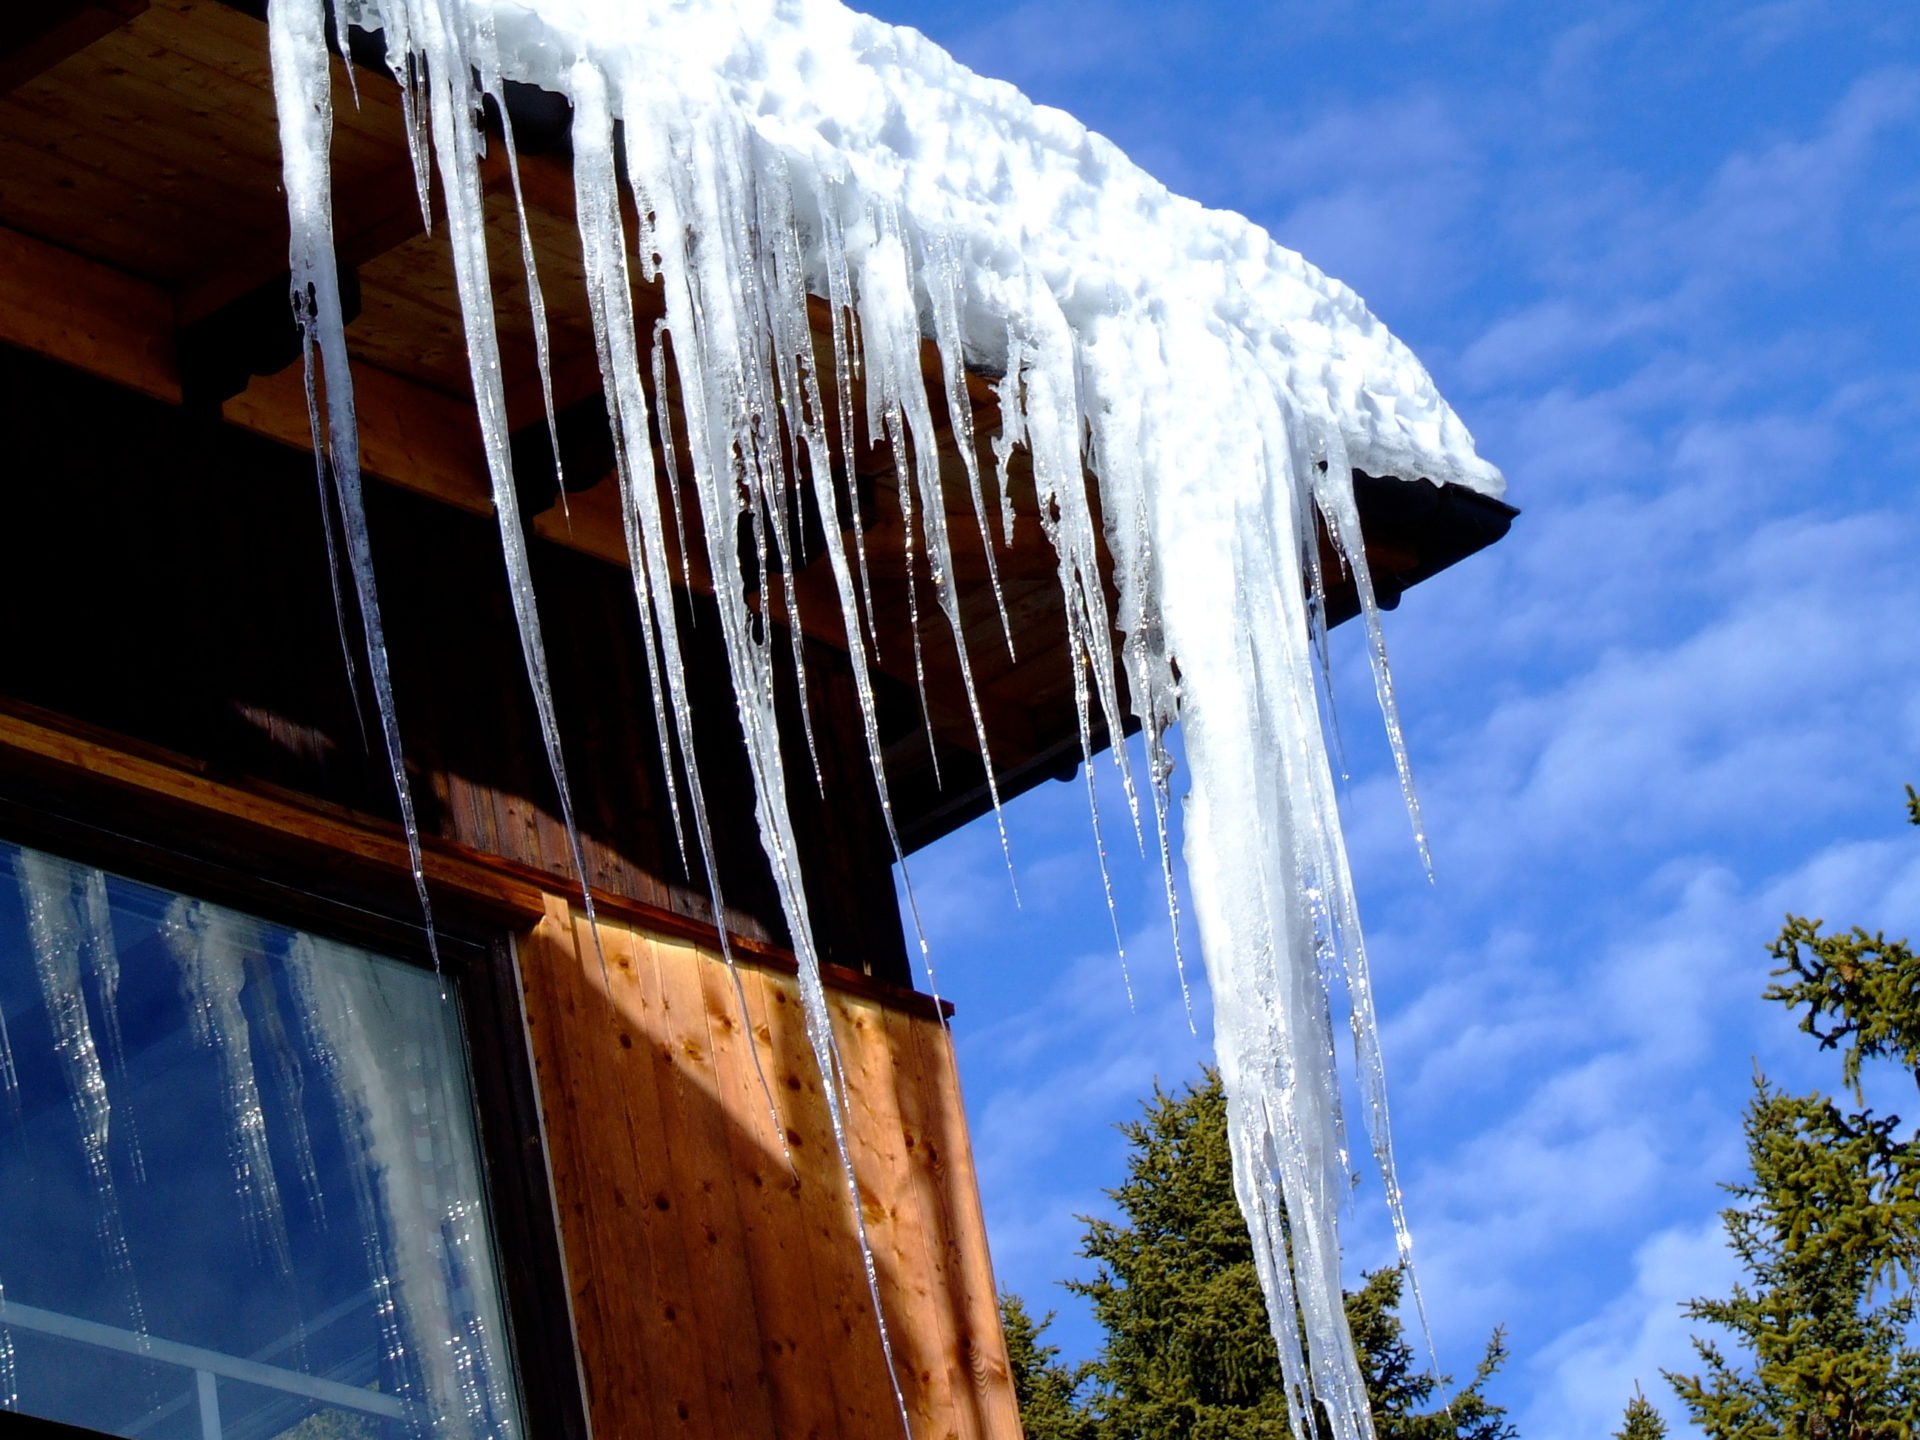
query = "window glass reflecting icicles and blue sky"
xmin=0 ymin=843 xmax=520 ymax=1440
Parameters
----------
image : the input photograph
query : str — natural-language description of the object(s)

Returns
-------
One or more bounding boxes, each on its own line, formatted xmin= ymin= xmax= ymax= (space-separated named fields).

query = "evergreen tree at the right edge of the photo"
xmin=1667 ymin=787 xmax=1920 ymax=1440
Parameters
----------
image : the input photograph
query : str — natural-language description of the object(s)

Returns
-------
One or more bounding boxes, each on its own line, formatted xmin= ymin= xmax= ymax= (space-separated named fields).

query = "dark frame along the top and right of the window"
xmin=0 ymin=764 xmax=591 ymax=1440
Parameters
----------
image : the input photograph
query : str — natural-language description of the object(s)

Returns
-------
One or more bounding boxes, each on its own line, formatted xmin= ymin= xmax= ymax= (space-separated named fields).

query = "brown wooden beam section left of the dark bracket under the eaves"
xmin=0 ymin=228 xmax=180 ymax=401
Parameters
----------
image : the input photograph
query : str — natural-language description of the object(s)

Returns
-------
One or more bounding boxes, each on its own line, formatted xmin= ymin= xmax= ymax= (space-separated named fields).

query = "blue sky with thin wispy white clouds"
xmin=872 ymin=0 xmax=1920 ymax=1440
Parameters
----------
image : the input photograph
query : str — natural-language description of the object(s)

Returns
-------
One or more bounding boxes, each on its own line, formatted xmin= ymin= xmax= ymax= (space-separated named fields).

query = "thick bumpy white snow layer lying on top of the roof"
xmin=480 ymin=0 xmax=1505 ymax=497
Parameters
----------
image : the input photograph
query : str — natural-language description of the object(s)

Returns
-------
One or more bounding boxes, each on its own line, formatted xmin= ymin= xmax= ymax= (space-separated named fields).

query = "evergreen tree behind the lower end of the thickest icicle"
xmin=1008 ymin=1069 xmax=1513 ymax=1440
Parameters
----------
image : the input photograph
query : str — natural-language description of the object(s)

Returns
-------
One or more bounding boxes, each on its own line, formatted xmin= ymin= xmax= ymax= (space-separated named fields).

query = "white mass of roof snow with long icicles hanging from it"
xmin=269 ymin=0 xmax=1500 ymax=1440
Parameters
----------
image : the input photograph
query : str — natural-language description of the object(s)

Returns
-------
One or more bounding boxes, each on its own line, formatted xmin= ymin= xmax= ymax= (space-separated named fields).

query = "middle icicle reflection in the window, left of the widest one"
xmin=161 ymin=897 xmax=294 ymax=1275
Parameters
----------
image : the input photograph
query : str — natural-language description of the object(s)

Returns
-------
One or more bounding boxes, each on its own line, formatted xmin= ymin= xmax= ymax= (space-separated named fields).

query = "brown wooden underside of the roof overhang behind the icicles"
xmin=0 ymin=0 xmax=1515 ymax=849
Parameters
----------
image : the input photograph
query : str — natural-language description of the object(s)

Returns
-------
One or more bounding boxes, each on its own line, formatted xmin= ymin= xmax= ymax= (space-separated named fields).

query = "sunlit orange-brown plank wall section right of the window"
xmin=520 ymin=899 xmax=1020 ymax=1440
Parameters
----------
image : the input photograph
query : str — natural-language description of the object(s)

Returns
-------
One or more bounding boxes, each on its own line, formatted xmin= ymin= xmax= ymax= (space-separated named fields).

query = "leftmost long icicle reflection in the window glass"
xmin=17 ymin=851 xmax=146 ymax=1334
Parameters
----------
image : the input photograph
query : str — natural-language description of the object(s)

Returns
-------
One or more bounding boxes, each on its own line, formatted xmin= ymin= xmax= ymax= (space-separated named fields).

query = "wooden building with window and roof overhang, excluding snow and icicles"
xmin=0 ymin=0 xmax=1511 ymax=1440
